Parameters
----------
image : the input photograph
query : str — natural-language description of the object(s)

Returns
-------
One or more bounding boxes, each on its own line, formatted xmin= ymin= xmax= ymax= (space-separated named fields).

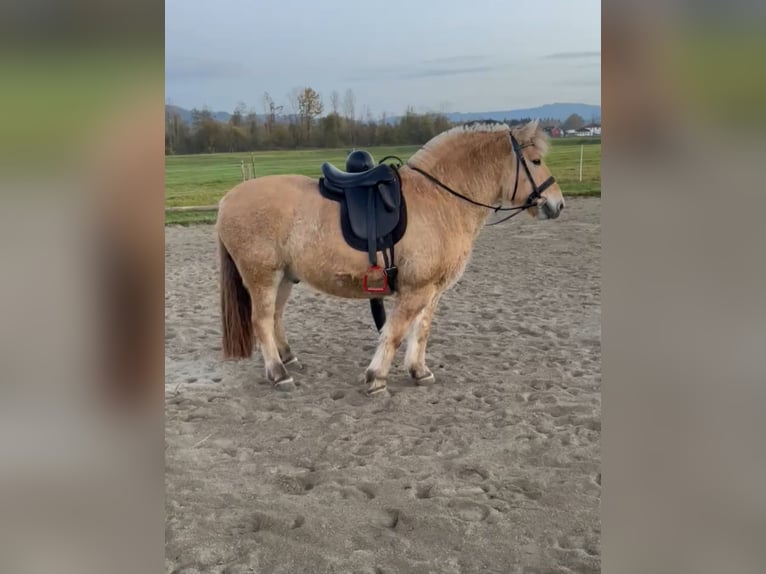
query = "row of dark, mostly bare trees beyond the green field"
xmin=165 ymin=87 xmax=576 ymax=155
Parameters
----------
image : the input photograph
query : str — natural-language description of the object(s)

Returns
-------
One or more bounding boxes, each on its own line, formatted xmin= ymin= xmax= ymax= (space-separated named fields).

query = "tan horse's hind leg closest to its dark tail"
xmin=249 ymin=276 xmax=294 ymax=390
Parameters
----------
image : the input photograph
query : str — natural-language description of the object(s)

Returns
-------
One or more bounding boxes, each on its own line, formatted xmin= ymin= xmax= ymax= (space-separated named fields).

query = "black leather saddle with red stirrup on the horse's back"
xmin=319 ymin=150 xmax=407 ymax=308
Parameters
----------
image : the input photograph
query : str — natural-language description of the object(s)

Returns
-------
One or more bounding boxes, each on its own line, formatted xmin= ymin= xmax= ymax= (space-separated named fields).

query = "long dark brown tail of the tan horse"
xmin=218 ymin=238 xmax=253 ymax=359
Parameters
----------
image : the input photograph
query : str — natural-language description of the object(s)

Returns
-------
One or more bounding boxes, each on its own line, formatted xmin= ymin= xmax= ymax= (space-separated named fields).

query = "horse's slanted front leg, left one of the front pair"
xmin=365 ymin=290 xmax=433 ymax=395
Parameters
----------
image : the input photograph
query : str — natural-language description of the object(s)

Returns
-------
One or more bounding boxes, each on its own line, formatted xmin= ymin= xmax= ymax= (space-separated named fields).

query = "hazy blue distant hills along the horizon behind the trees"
xmin=165 ymin=103 xmax=601 ymax=124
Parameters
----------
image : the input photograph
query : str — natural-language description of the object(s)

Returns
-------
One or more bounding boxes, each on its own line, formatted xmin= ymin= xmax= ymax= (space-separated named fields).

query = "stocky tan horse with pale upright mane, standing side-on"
xmin=216 ymin=120 xmax=564 ymax=395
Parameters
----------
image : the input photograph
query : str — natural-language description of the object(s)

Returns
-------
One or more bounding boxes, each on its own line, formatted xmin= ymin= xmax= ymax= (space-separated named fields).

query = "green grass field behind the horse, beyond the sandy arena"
xmin=165 ymin=137 xmax=601 ymax=224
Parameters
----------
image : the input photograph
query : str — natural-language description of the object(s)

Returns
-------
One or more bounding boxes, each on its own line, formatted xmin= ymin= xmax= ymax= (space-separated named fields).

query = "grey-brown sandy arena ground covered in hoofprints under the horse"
xmin=165 ymin=198 xmax=601 ymax=574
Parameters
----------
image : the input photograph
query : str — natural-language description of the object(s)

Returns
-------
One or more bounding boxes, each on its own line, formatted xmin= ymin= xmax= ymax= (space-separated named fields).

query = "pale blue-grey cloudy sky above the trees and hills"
xmin=165 ymin=0 xmax=601 ymax=118
